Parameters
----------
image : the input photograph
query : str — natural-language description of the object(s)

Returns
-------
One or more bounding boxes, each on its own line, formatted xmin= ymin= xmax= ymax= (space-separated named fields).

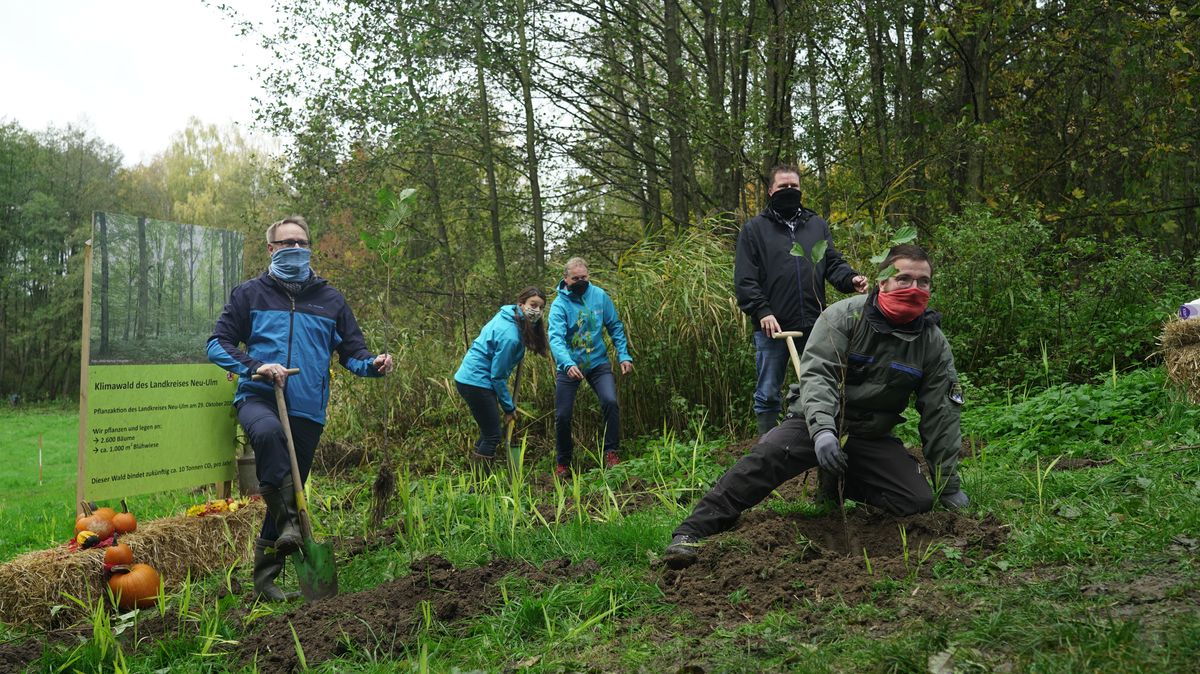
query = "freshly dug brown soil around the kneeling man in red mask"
xmin=659 ymin=506 xmax=1007 ymax=631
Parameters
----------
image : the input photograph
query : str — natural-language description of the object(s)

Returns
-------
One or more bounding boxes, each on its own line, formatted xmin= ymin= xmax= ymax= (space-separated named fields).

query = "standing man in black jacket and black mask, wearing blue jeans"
xmin=733 ymin=166 xmax=868 ymax=435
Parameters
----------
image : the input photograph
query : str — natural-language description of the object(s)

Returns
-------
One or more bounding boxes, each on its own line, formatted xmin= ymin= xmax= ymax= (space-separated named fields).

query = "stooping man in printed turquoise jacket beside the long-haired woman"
xmin=548 ymin=258 xmax=634 ymax=477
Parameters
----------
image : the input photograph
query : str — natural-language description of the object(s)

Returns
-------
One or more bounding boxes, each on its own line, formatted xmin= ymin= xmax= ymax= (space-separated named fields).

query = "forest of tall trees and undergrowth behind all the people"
xmin=0 ymin=0 xmax=1200 ymax=435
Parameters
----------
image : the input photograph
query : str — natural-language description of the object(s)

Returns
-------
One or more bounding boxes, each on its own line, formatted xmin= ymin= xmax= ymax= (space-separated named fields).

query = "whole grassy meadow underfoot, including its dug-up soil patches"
xmin=0 ymin=369 xmax=1200 ymax=672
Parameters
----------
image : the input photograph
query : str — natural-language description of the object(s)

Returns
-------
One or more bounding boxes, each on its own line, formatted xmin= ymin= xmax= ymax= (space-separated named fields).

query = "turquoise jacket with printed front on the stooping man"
xmin=548 ymin=281 xmax=634 ymax=374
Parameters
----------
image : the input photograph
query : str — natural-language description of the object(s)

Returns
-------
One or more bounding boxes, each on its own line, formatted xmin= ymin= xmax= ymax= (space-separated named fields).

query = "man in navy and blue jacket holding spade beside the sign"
xmin=208 ymin=216 xmax=394 ymax=601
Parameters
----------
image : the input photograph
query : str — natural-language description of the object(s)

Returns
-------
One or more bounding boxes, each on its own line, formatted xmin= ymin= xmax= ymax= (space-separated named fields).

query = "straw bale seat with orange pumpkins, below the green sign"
xmin=0 ymin=499 xmax=266 ymax=628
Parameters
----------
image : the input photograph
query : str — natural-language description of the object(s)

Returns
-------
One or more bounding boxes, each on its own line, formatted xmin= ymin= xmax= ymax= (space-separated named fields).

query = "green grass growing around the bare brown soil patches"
xmin=0 ymin=369 xmax=1200 ymax=672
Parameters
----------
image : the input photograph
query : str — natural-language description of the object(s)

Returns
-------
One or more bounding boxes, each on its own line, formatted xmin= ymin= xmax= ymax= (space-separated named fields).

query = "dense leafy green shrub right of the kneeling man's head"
xmin=930 ymin=207 xmax=1188 ymax=391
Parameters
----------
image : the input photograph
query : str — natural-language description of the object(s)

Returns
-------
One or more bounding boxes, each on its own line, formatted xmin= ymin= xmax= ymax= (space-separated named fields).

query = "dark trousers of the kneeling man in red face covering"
xmin=674 ymin=416 xmax=934 ymax=538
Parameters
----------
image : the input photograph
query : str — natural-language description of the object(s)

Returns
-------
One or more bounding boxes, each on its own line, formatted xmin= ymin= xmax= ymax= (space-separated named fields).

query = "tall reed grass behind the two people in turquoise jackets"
xmin=329 ymin=229 xmax=755 ymax=470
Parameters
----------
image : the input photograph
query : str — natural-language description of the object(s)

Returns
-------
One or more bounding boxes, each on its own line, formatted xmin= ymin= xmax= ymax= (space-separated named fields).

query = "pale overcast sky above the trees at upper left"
xmin=0 ymin=0 xmax=268 ymax=166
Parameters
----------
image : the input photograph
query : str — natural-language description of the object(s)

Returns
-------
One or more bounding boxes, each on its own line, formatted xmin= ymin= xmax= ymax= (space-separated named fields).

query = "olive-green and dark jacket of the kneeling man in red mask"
xmin=788 ymin=291 xmax=962 ymax=479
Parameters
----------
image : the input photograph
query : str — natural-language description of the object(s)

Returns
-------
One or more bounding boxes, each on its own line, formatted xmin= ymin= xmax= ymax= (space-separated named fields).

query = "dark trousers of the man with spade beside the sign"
xmin=238 ymin=396 xmax=325 ymax=541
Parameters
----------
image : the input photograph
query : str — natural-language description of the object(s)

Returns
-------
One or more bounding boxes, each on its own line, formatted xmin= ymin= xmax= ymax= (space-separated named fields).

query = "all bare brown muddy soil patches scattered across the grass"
xmin=7 ymin=431 xmax=1193 ymax=673
